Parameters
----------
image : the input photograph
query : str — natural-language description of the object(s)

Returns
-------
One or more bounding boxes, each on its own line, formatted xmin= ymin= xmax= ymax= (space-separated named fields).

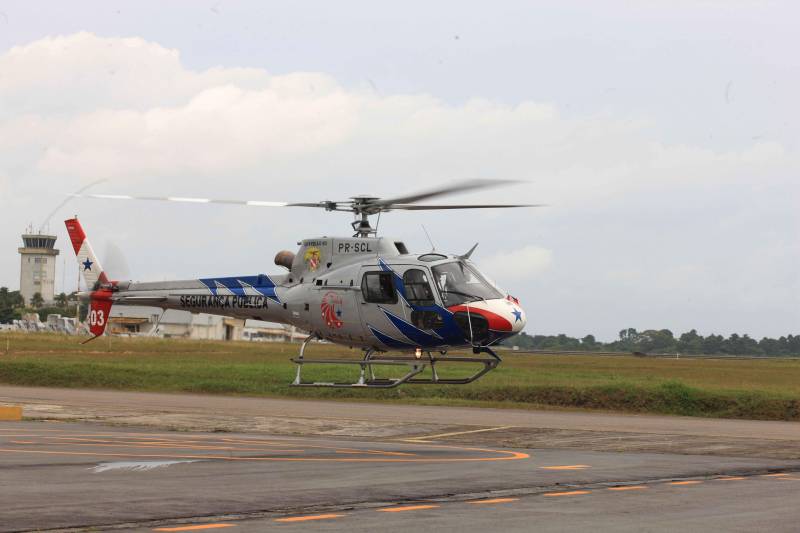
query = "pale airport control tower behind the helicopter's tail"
xmin=18 ymin=228 xmax=58 ymax=304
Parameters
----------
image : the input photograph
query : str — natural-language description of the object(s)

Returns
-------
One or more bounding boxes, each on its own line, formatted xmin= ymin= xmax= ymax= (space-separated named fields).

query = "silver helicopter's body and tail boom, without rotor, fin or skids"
xmin=106 ymin=237 xmax=526 ymax=351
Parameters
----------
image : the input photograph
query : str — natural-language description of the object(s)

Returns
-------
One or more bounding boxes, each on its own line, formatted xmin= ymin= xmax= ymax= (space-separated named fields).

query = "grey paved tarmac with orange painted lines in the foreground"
xmin=0 ymin=387 xmax=800 ymax=531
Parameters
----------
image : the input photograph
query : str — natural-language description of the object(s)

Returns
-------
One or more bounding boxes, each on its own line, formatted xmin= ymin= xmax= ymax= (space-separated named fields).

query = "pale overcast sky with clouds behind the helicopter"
xmin=0 ymin=0 xmax=800 ymax=339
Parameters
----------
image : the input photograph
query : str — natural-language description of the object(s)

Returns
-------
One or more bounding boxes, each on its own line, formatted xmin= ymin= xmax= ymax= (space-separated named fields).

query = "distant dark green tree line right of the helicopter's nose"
xmin=503 ymin=328 xmax=800 ymax=356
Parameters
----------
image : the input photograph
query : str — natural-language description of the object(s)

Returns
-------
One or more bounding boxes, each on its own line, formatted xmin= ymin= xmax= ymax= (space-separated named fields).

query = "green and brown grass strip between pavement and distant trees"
xmin=0 ymin=333 xmax=800 ymax=420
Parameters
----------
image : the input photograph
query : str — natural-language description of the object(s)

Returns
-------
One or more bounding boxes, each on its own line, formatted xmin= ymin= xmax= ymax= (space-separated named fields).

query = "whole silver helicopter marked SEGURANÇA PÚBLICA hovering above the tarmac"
xmin=65 ymin=180 xmax=541 ymax=388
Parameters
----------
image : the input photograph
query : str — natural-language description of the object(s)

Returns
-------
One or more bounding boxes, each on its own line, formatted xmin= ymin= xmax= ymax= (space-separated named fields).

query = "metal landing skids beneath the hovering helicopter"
xmin=291 ymin=335 xmax=501 ymax=389
